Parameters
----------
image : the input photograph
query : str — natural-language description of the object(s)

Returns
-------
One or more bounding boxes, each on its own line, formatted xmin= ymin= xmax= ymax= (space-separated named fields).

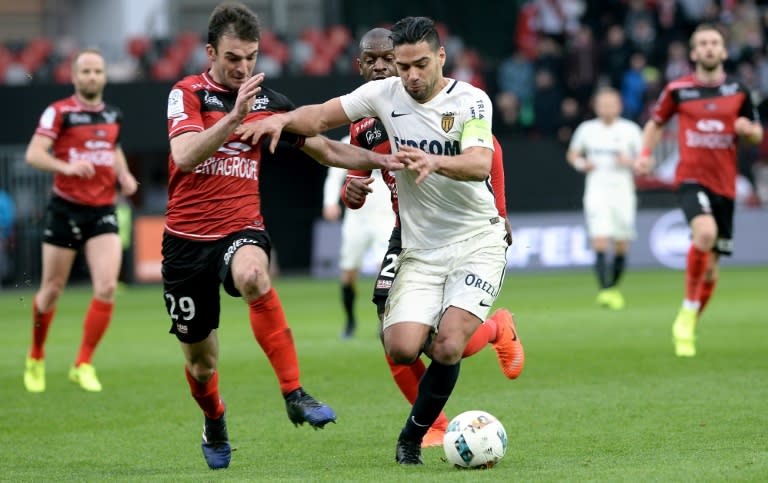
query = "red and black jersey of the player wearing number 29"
xmin=166 ymin=73 xmax=294 ymax=240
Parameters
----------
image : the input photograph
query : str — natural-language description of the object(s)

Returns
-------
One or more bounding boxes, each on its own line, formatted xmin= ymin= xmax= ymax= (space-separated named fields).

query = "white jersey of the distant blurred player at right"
xmin=568 ymin=118 xmax=643 ymax=199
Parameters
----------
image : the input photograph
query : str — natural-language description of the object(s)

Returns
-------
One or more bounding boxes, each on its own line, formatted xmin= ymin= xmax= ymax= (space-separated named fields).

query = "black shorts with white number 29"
xmin=162 ymin=230 xmax=272 ymax=344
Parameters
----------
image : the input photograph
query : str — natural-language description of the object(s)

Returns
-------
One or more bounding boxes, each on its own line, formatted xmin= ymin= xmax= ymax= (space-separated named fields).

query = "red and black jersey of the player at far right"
xmin=652 ymin=74 xmax=758 ymax=199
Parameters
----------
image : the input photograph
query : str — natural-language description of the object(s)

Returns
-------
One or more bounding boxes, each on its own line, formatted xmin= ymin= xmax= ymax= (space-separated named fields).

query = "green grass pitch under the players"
xmin=0 ymin=268 xmax=768 ymax=482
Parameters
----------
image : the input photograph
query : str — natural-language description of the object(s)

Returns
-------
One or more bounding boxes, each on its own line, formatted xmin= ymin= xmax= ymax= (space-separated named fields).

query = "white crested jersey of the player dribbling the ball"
xmin=341 ymin=77 xmax=499 ymax=248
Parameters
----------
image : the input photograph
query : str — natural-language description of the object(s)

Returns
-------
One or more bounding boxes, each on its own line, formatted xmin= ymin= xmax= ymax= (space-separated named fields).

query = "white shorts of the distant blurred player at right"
xmin=584 ymin=192 xmax=637 ymax=240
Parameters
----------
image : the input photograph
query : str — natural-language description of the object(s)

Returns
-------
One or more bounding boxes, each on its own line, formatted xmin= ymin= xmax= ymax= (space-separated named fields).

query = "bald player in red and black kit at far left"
xmin=24 ymin=49 xmax=137 ymax=398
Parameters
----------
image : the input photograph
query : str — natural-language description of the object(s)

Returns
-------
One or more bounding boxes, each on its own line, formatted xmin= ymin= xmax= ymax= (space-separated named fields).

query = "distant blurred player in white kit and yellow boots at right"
xmin=566 ymin=88 xmax=642 ymax=310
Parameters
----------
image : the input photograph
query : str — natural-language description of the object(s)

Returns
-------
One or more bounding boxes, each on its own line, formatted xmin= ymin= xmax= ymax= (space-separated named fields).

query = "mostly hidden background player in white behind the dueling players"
xmin=323 ymin=154 xmax=395 ymax=338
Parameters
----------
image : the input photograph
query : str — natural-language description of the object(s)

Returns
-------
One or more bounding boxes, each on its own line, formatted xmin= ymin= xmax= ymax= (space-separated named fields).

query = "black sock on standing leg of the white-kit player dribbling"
xmin=400 ymin=361 xmax=461 ymax=441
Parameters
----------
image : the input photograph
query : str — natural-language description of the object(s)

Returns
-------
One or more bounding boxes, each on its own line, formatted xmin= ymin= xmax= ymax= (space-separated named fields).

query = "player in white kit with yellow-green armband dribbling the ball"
xmin=237 ymin=17 xmax=507 ymax=464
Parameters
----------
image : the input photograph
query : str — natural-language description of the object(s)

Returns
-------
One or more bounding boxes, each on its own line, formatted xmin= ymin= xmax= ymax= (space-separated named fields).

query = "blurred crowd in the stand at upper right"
xmin=494 ymin=0 xmax=768 ymax=142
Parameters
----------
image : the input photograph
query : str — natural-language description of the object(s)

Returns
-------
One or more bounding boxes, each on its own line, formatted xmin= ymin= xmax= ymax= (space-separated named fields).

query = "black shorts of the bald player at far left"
xmin=43 ymin=195 xmax=118 ymax=250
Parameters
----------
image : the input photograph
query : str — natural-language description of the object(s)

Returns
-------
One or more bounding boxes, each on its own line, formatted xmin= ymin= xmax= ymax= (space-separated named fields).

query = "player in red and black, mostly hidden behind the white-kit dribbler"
xmin=341 ymin=28 xmax=525 ymax=447
